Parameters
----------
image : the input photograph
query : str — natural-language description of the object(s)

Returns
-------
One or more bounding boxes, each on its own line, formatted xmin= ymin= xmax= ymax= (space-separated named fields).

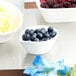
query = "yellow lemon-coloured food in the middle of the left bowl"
xmin=0 ymin=13 xmax=11 ymax=33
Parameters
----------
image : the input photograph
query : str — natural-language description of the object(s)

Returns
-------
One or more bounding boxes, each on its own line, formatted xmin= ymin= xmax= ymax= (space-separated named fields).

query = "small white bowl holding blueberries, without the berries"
xmin=19 ymin=25 xmax=58 ymax=54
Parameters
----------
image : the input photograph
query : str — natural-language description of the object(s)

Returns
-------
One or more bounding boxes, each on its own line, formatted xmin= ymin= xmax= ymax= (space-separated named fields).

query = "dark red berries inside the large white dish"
xmin=40 ymin=0 xmax=76 ymax=8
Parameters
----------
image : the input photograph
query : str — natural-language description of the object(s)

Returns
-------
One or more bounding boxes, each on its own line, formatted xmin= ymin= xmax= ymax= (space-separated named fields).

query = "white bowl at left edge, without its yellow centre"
xmin=0 ymin=1 xmax=23 ymax=43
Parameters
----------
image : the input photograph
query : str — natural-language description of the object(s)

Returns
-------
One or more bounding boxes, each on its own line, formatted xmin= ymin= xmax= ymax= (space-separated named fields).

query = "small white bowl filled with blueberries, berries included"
xmin=20 ymin=25 xmax=58 ymax=54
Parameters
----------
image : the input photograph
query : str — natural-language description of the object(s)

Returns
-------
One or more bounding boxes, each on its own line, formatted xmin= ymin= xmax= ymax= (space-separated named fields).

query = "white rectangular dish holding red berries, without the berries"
xmin=36 ymin=0 xmax=76 ymax=23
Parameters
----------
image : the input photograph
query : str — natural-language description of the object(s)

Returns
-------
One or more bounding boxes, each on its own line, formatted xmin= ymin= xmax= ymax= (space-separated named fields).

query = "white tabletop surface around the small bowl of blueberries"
xmin=0 ymin=9 xmax=76 ymax=69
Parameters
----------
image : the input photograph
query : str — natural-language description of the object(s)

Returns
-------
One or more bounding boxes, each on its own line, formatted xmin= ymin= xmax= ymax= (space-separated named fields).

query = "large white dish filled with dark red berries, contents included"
xmin=36 ymin=0 xmax=76 ymax=23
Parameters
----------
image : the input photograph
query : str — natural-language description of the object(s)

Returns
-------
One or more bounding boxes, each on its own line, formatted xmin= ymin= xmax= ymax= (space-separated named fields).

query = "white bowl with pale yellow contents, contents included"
xmin=0 ymin=1 xmax=23 ymax=43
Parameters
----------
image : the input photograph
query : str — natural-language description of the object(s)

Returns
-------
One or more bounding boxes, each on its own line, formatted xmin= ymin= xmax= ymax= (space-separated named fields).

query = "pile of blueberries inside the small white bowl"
xmin=22 ymin=27 xmax=57 ymax=42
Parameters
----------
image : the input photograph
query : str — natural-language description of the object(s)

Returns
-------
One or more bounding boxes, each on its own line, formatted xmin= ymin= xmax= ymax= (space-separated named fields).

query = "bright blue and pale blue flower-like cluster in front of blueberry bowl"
xmin=23 ymin=55 xmax=70 ymax=76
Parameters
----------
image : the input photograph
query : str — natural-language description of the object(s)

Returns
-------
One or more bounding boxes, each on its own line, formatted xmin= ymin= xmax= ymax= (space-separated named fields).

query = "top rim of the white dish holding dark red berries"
xmin=36 ymin=0 xmax=76 ymax=10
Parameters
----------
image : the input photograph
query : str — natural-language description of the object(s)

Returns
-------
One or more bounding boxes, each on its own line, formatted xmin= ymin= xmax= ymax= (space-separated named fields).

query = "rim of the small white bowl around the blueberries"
xmin=19 ymin=25 xmax=59 ymax=44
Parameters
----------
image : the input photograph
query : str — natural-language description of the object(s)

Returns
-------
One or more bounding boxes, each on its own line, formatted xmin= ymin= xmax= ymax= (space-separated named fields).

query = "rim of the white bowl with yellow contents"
xmin=0 ymin=1 xmax=23 ymax=35
